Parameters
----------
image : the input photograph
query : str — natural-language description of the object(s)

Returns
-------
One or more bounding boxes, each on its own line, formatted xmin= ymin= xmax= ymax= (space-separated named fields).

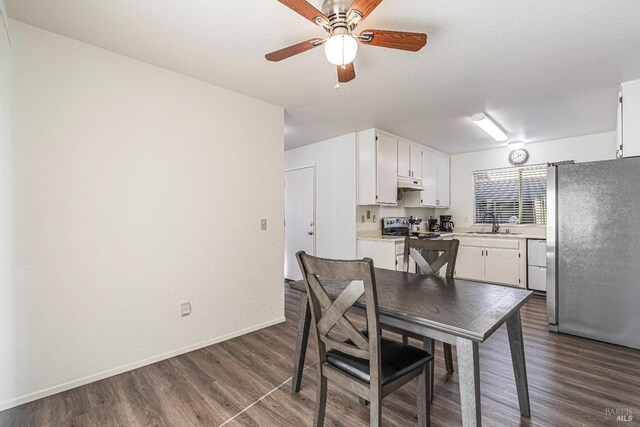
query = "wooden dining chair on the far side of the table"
xmin=402 ymin=237 xmax=460 ymax=374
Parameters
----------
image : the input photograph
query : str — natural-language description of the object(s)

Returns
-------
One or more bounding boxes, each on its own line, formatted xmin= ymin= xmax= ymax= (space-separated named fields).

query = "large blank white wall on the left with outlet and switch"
xmin=0 ymin=21 xmax=284 ymax=410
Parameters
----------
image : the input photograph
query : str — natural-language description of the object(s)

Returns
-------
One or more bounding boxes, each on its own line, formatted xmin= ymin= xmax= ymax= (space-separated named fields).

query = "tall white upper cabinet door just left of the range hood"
xmin=376 ymin=133 xmax=398 ymax=205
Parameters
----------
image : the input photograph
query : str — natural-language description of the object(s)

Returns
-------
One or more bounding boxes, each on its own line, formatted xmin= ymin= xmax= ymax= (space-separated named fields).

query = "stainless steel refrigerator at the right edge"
xmin=547 ymin=157 xmax=640 ymax=349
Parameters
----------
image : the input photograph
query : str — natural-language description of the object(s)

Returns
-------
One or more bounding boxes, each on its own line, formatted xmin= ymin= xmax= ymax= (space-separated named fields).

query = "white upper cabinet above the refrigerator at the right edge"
xmin=618 ymin=80 xmax=640 ymax=157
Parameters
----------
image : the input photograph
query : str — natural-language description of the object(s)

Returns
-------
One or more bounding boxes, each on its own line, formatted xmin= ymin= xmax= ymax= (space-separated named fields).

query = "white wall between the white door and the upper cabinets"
xmin=284 ymin=133 xmax=356 ymax=259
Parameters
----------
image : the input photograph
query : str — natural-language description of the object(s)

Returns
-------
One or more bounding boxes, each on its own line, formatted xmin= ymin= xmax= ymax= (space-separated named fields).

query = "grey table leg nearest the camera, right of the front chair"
xmin=456 ymin=338 xmax=482 ymax=427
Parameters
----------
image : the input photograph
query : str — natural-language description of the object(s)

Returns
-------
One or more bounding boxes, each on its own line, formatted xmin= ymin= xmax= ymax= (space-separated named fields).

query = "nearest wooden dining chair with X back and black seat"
xmin=296 ymin=251 xmax=433 ymax=427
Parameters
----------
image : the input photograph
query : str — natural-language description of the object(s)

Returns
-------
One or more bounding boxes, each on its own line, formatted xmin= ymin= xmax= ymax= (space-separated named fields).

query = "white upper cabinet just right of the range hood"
xmin=405 ymin=149 xmax=449 ymax=208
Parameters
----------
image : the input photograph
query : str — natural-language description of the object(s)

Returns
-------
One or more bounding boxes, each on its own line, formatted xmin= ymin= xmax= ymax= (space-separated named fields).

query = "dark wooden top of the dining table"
xmin=289 ymin=268 xmax=533 ymax=342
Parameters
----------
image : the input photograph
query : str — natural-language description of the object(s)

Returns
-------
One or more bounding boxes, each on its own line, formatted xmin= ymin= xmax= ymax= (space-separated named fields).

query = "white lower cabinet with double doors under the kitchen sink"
xmin=456 ymin=237 xmax=526 ymax=287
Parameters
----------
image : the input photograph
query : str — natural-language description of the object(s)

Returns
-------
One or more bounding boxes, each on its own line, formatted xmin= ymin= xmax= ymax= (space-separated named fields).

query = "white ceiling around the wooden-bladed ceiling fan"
xmin=7 ymin=0 xmax=640 ymax=153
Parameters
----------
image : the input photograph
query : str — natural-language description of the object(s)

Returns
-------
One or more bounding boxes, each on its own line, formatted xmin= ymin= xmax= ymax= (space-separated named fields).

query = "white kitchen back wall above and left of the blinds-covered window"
xmin=438 ymin=132 xmax=616 ymax=227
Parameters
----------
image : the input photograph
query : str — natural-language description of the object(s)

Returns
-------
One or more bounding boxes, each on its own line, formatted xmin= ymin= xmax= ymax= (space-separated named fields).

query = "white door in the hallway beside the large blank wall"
xmin=284 ymin=166 xmax=315 ymax=280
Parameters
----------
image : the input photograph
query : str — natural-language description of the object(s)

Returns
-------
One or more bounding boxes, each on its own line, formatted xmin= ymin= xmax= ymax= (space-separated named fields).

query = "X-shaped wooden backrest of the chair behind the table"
xmin=403 ymin=237 xmax=460 ymax=279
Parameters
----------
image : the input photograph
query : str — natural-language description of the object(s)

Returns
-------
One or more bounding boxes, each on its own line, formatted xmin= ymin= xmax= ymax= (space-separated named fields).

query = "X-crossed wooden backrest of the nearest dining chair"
xmin=296 ymin=251 xmax=380 ymax=372
